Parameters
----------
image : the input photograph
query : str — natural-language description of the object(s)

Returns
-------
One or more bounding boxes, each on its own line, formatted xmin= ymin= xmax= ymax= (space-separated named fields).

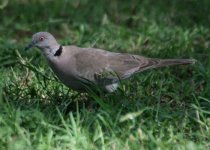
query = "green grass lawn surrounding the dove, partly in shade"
xmin=0 ymin=0 xmax=210 ymax=150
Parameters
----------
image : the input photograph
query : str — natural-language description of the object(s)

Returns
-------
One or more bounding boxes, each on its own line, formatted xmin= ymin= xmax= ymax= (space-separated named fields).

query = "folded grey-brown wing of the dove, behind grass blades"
xmin=74 ymin=48 xmax=146 ymax=84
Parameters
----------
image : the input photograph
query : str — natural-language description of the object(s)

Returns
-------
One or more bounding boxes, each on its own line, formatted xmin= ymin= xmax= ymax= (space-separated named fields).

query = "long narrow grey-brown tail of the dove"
xmin=139 ymin=58 xmax=196 ymax=71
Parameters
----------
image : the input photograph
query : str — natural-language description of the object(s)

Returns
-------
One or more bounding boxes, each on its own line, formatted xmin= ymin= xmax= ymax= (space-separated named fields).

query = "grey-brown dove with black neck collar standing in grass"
xmin=26 ymin=32 xmax=195 ymax=92
